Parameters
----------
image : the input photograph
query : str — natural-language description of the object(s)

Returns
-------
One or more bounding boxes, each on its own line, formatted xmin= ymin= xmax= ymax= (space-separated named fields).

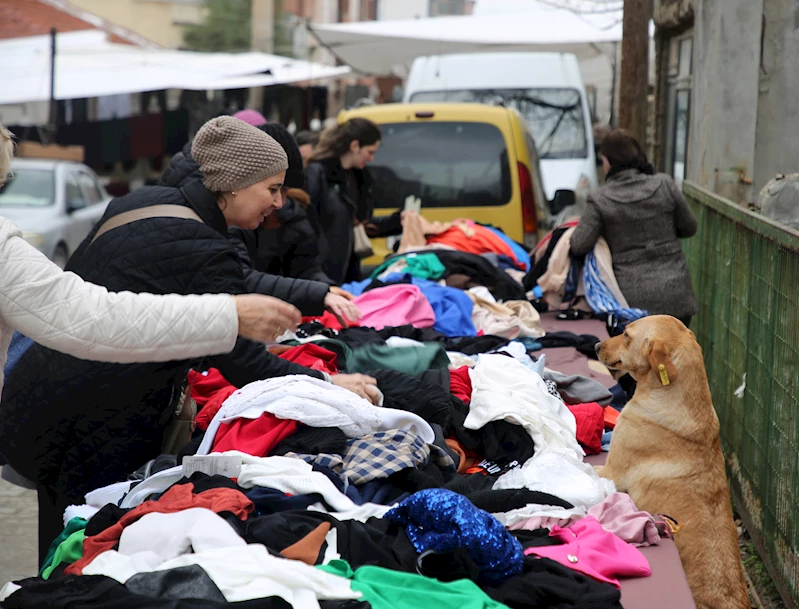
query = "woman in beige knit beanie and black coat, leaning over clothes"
xmin=0 ymin=116 xmax=378 ymax=560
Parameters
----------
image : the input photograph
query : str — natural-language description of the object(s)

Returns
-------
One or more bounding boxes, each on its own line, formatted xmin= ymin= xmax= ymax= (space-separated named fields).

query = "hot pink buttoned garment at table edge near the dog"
xmin=524 ymin=516 xmax=652 ymax=588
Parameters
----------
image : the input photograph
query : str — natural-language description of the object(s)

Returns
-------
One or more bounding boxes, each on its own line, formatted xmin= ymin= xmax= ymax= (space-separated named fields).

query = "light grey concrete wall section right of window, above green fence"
xmin=687 ymin=0 xmax=764 ymax=202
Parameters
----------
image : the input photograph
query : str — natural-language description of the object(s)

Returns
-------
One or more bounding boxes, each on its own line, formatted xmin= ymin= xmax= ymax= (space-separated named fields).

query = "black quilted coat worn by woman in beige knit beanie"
xmin=0 ymin=180 xmax=322 ymax=503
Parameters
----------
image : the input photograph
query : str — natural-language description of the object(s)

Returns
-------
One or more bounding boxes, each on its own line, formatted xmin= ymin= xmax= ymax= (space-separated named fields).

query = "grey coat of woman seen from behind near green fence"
xmin=571 ymin=169 xmax=699 ymax=318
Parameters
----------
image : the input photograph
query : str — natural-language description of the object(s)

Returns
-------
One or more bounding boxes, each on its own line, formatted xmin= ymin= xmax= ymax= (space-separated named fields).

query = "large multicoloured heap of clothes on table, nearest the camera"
xmin=0 ymin=223 xmax=668 ymax=609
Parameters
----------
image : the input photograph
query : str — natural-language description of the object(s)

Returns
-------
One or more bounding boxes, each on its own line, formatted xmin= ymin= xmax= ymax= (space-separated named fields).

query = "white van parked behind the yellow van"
xmin=404 ymin=53 xmax=597 ymax=220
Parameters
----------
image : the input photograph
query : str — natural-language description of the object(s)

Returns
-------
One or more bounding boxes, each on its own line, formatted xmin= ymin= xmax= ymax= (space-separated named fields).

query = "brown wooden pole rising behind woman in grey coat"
xmin=619 ymin=0 xmax=652 ymax=147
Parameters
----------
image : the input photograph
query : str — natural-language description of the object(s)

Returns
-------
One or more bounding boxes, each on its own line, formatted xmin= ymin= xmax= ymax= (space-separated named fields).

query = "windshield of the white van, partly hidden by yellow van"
xmin=411 ymin=89 xmax=588 ymax=159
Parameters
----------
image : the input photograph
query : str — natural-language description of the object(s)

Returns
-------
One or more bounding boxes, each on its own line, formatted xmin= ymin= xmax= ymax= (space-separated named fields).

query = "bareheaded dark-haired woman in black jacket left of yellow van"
xmin=305 ymin=118 xmax=402 ymax=284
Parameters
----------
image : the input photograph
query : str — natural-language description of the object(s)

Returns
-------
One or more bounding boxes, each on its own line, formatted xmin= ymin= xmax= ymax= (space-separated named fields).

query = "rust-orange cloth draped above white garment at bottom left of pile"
xmin=70 ymin=484 xmax=255 ymax=575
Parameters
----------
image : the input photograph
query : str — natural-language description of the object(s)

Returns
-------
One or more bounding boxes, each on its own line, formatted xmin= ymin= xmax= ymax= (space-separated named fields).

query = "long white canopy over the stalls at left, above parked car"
xmin=0 ymin=30 xmax=350 ymax=105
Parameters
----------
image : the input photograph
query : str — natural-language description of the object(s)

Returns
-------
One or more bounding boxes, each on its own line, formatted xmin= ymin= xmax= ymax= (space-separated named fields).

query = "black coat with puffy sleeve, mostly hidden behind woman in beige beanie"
xmin=158 ymin=143 xmax=330 ymax=316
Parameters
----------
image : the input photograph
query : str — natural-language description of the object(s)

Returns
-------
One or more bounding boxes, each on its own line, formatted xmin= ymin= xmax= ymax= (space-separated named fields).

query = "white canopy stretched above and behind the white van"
xmin=309 ymin=0 xmax=622 ymax=76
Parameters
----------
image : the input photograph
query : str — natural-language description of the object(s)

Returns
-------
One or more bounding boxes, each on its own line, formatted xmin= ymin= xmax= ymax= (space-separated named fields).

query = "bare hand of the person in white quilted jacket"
xmin=233 ymin=294 xmax=302 ymax=343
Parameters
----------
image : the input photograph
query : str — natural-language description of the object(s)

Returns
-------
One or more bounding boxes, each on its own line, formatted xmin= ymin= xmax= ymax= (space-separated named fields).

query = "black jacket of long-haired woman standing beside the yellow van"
xmin=305 ymin=158 xmax=402 ymax=284
